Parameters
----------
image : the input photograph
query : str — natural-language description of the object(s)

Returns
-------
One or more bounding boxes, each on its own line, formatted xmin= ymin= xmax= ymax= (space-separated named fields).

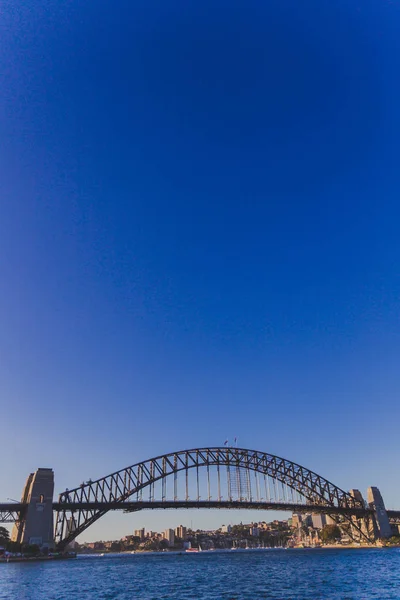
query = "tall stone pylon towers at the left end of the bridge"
xmin=11 ymin=469 xmax=54 ymax=548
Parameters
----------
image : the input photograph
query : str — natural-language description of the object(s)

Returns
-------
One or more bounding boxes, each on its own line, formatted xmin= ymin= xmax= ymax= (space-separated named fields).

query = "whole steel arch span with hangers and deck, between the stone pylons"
xmin=54 ymin=447 xmax=368 ymax=549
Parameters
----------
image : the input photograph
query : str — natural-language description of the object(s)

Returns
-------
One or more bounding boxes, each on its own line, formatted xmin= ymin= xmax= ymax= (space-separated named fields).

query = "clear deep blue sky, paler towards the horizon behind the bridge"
xmin=0 ymin=0 xmax=400 ymax=539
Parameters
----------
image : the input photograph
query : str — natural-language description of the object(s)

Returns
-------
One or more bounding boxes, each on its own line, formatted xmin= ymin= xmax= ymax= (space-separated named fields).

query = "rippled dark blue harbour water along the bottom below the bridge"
xmin=0 ymin=548 xmax=400 ymax=600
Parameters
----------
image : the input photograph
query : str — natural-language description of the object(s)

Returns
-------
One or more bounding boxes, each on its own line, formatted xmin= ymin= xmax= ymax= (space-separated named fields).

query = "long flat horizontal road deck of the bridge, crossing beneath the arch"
xmin=0 ymin=500 xmax=400 ymax=523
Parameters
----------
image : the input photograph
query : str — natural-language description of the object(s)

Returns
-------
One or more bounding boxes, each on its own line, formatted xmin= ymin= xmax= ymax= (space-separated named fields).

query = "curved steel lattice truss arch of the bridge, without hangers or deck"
xmin=55 ymin=447 xmax=364 ymax=548
